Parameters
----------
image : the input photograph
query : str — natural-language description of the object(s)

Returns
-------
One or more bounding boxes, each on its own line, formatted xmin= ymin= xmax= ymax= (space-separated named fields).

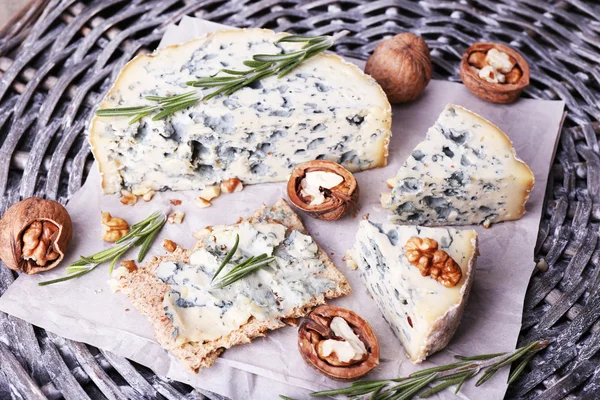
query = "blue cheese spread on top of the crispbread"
xmin=155 ymin=221 xmax=336 ymax=344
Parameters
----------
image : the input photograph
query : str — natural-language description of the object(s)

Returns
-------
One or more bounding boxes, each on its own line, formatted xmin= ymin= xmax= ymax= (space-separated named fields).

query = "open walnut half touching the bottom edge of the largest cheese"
xmin=287 ymin=160 xmax=359 ymax=221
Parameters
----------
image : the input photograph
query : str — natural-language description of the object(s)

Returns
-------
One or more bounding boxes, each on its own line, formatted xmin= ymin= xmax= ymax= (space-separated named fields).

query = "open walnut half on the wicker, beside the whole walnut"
xmin=460 ymin=43 xmax=529 ymax=103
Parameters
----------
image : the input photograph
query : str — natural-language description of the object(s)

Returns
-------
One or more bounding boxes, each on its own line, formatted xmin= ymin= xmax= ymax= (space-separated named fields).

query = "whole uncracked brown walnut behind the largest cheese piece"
xmin=365 ymin=32 xmax=432 ymax=103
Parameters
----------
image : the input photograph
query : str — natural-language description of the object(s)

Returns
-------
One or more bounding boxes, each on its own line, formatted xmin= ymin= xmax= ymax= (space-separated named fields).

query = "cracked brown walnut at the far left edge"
xmin=0 ymin=197 xmax=73 ymax=274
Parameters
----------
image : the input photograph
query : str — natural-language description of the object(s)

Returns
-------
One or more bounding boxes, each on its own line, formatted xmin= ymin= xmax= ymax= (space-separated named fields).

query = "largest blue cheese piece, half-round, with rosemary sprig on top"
xmin=89 ymin=29 xmax=391 ymax=195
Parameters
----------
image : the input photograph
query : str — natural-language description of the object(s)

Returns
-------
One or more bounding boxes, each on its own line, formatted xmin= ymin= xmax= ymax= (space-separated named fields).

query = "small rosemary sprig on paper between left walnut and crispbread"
xmin=38 ymin=211 xmax=168 ymax=286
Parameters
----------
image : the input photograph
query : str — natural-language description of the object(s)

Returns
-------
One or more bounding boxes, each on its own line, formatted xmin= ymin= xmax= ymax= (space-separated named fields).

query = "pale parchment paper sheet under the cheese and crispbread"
xmin=0 ymin=18 xmax=564 ymax=400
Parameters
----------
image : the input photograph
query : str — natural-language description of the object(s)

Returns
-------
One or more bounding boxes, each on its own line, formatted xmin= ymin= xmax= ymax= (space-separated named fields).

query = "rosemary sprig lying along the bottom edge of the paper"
xmin=311 ymin=340 xmax=549 ymax=400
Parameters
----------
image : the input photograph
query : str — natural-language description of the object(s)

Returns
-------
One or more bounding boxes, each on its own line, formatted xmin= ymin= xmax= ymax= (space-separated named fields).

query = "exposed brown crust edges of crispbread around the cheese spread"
xmin=114 ymin=200 xmax=350 ymax=372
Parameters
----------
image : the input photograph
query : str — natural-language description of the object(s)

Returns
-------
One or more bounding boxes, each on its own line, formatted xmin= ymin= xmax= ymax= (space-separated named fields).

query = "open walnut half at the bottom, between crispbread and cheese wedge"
xmin=298 ymin=305 xmax=379 ymax=381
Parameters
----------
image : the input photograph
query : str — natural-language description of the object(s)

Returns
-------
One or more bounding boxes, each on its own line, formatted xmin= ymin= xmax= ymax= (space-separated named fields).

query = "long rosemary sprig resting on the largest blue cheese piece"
xmin=96 ymin=31 xmax=349 ymax=124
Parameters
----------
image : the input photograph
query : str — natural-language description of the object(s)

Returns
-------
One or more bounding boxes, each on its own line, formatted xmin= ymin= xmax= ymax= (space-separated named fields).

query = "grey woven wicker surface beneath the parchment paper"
xmin=0 ymin=0 xmax=600 ymax=400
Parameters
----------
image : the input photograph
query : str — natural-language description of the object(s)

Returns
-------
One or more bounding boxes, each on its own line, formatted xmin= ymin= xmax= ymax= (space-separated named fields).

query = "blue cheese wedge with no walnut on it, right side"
xmin=381 ymin=105 xmax=534 ymax=227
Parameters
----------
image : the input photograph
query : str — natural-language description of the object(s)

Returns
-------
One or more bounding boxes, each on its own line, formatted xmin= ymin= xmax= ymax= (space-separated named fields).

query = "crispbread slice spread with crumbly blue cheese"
xmin=111 ymin=200 xmax=350 ymax=371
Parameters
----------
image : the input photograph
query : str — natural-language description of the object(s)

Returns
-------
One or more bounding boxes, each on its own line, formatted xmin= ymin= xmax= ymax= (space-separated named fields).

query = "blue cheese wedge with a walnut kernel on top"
xmin=346 ymin=220 xmax=478 ymax=363
